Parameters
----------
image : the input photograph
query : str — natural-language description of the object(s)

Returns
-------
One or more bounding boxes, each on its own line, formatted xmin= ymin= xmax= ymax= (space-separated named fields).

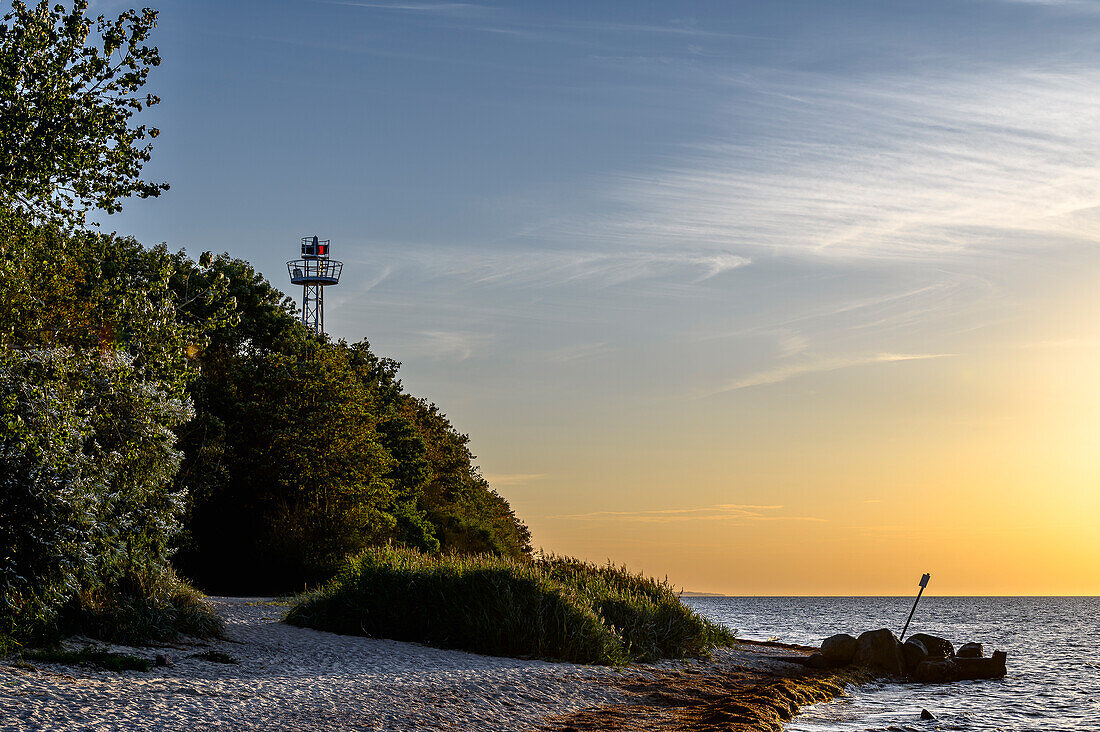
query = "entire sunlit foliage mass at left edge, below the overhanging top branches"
xmin=0 ymin=208 xmax=223 ymax=638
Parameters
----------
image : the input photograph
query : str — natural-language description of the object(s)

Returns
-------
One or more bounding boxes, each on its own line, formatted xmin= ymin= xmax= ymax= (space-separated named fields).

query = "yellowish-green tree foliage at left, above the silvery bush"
xmin=0 ymin=206 xmax=234 ymax=387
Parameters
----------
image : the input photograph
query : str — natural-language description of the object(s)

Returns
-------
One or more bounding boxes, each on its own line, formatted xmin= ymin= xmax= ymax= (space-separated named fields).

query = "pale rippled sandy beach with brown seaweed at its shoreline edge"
xmin=0 ymin=598 xmax=844 ymax=732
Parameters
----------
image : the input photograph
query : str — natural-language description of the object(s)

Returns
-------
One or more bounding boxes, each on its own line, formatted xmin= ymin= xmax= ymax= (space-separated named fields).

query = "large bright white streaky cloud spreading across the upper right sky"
xmin=571 ymin=67 xmax=1100 ymax=261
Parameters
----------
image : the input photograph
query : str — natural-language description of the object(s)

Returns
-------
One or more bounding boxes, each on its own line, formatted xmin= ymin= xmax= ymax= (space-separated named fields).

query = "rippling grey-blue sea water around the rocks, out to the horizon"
xmin=684 ymin=597 xmax=1100 ymax=732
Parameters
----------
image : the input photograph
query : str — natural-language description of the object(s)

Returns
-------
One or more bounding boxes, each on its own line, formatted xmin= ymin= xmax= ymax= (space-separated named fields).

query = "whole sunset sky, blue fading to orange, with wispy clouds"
xmin=92 ymin=0 xmax=1100 ymax=594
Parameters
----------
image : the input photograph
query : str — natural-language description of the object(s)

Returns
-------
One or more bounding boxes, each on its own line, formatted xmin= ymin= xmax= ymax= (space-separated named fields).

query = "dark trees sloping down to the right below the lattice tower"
xmin=173 ymin=255 xmax=529 ymax=592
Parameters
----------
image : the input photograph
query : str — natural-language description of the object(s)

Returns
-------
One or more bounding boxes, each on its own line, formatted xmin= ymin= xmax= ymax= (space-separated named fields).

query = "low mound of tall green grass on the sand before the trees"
xmin=286 ymin=547 xmax=734 ymax=664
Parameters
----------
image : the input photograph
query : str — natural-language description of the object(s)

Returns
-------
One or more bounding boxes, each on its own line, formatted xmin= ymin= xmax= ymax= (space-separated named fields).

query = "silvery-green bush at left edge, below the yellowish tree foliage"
xmin=0 ymin=348 xmax=189 ymax=640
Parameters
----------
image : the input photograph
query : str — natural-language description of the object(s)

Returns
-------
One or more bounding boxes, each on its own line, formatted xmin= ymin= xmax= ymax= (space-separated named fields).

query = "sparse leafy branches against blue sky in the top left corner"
xmin=0 ymin=0 xmax=168 ymax=225
